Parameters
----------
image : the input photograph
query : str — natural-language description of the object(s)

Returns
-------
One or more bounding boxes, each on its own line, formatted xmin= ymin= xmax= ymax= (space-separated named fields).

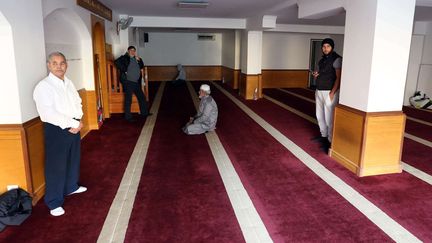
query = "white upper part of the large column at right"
xmin=340 ymin=0 xmax=416 ymax=112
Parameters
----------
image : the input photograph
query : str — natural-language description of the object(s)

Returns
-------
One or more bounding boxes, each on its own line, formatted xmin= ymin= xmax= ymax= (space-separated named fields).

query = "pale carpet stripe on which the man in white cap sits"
xmin=187 ymin=82 xmax=273 ymax=242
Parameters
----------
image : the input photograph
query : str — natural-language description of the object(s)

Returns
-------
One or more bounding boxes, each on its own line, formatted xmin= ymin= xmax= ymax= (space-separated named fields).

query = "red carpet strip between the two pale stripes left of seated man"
xmin=126 ymin=85 xmax=244 ymax=242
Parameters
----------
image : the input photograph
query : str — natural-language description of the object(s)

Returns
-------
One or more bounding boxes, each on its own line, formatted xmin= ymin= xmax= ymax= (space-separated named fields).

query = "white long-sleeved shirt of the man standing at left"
xmin=33 ymin=73 xmax=83 ymax=129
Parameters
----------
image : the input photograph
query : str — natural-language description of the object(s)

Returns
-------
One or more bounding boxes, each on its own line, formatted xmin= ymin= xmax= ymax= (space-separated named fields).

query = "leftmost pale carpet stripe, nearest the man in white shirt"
xmin=97 ymin=82 xmax=165 ymax=243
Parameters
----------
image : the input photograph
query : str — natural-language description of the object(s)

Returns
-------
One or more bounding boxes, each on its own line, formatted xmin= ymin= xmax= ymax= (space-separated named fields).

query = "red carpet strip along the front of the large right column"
xmin=256 ymin=86 xmax=432 ymax=241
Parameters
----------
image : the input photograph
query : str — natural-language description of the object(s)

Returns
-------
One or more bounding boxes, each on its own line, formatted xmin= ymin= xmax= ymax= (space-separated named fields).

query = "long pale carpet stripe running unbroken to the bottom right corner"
xmin=213 ymin=82 xmax=421 ymax=242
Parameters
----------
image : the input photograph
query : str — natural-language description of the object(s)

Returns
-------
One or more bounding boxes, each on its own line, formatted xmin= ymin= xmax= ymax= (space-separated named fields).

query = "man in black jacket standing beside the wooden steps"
xmin=115 ymin=46 xmax=151 ymax=122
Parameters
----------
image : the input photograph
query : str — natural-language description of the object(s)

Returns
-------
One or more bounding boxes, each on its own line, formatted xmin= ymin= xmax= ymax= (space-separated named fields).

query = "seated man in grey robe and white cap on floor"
xmin=183 ymin=84 xmax=218 ymax=135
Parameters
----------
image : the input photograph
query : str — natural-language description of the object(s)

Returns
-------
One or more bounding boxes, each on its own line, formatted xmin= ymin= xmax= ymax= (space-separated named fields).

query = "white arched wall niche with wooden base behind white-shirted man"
xmin=44 ymin=8 xmax=99 ymax=135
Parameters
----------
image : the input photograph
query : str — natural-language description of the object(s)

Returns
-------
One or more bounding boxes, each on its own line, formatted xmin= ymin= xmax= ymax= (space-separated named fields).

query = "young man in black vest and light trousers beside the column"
xmin=312 ymin=38 xmax=342 ymax=153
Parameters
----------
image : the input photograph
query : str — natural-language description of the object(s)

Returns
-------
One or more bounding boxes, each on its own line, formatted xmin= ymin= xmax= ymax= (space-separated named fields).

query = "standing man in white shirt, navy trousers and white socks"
xmin=33 ymin=52 xmax=87 ymax=216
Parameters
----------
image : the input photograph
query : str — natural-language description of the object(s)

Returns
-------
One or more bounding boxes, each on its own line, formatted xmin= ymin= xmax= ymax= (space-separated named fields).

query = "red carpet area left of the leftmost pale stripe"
xmin=0 ymin=83 xmax=158 ymax=243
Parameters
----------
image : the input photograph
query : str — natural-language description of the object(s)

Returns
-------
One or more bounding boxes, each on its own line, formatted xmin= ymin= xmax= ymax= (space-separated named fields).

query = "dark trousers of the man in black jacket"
xmin=123 ymin=81 xmax=148 ymax=119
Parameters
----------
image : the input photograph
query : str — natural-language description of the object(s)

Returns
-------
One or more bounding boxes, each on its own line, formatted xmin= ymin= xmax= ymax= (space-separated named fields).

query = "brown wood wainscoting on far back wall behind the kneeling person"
xmin=147 ymin=66 xmax=222 ymax=81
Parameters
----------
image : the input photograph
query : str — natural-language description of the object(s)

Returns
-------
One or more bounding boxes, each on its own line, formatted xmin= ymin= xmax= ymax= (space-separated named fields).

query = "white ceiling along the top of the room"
xmin=99 ymin=0 xmax=432 ymax=26
